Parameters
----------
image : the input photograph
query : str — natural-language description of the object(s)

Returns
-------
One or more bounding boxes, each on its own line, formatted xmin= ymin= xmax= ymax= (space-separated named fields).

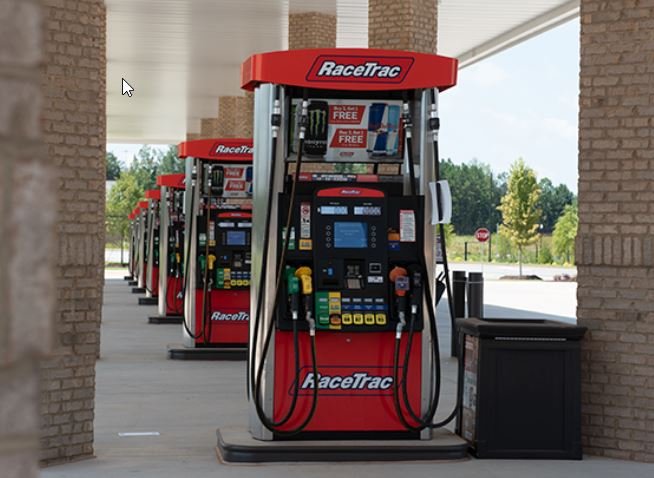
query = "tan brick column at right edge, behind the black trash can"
xmin=576 ymin=0 xmax=654 ymax=462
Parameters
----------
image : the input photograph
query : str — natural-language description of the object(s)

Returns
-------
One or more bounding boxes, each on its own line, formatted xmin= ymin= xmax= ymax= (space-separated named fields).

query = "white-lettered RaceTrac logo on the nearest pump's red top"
xmin=307 ymin=55 xmax=413 ymax=83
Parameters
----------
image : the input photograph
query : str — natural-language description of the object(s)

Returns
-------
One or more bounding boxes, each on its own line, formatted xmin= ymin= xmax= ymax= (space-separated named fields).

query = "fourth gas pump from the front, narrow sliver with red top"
xmin=139 ymin=189 xmax=161 ymax=305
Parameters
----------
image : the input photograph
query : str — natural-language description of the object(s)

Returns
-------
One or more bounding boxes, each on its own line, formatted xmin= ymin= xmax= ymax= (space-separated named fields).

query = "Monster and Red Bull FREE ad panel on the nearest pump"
xmin=290 ymin=100 xmax=402 ymax=162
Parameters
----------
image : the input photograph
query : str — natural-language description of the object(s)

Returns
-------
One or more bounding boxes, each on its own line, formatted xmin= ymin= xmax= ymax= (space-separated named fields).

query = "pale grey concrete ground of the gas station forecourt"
xmin=42 ymin=271 xmax=654 ymax=478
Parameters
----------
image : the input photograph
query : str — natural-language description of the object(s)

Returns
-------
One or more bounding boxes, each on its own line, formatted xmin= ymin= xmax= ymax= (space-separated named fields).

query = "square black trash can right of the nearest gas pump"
xmin=457 ymin=318 xmax=586 ymax=460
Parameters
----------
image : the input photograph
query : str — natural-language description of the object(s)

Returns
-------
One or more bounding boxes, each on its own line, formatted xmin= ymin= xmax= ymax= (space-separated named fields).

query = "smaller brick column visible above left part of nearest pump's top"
xmin=288 ymin=12 xmax=336 ymax=50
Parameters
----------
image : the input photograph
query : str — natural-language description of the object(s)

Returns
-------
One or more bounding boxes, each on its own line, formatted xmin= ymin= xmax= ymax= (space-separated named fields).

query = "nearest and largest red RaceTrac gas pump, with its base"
xmin=219 ymin=49 xmax=466 ymax=461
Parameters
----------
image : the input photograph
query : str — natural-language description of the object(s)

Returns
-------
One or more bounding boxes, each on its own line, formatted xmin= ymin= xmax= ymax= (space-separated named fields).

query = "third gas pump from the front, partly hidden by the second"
xmin=148 ymin=174 xmax=186 ymax=324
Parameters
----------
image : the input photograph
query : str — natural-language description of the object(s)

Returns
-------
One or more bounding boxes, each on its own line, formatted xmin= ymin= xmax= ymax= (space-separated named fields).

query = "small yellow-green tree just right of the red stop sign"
xmin=498 ymin=158 xmax=541 ymax=277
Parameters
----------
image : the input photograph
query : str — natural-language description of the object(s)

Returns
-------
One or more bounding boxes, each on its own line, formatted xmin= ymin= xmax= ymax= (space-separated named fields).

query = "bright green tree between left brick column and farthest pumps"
xmin=106 ymin=171 xmax=144 ymax=245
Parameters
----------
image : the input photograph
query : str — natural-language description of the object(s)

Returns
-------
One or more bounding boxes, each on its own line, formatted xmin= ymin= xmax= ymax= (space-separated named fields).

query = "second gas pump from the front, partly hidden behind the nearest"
xmin=169 ymin=139 xmax=252 ymax=359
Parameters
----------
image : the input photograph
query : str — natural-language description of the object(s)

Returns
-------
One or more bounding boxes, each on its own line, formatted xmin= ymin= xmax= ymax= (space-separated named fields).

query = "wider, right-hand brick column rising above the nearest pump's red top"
xmin=368 ymin=0 xmax=438 ymax=53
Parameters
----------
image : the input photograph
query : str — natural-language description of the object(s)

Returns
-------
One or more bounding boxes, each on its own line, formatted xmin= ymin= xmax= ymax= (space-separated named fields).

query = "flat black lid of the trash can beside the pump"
xmin=456 ymin=318 xmax=587 ymax=340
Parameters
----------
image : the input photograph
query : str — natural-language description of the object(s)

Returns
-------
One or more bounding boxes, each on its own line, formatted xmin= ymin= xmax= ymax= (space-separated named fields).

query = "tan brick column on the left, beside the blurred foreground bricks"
xmin=40 ymin=0 xmax=106 ymax=463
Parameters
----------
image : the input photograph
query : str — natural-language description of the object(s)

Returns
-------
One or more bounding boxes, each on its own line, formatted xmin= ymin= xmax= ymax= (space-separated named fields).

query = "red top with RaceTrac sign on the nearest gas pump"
xmin=241 ymin=48 xmax=458 ymax=91
